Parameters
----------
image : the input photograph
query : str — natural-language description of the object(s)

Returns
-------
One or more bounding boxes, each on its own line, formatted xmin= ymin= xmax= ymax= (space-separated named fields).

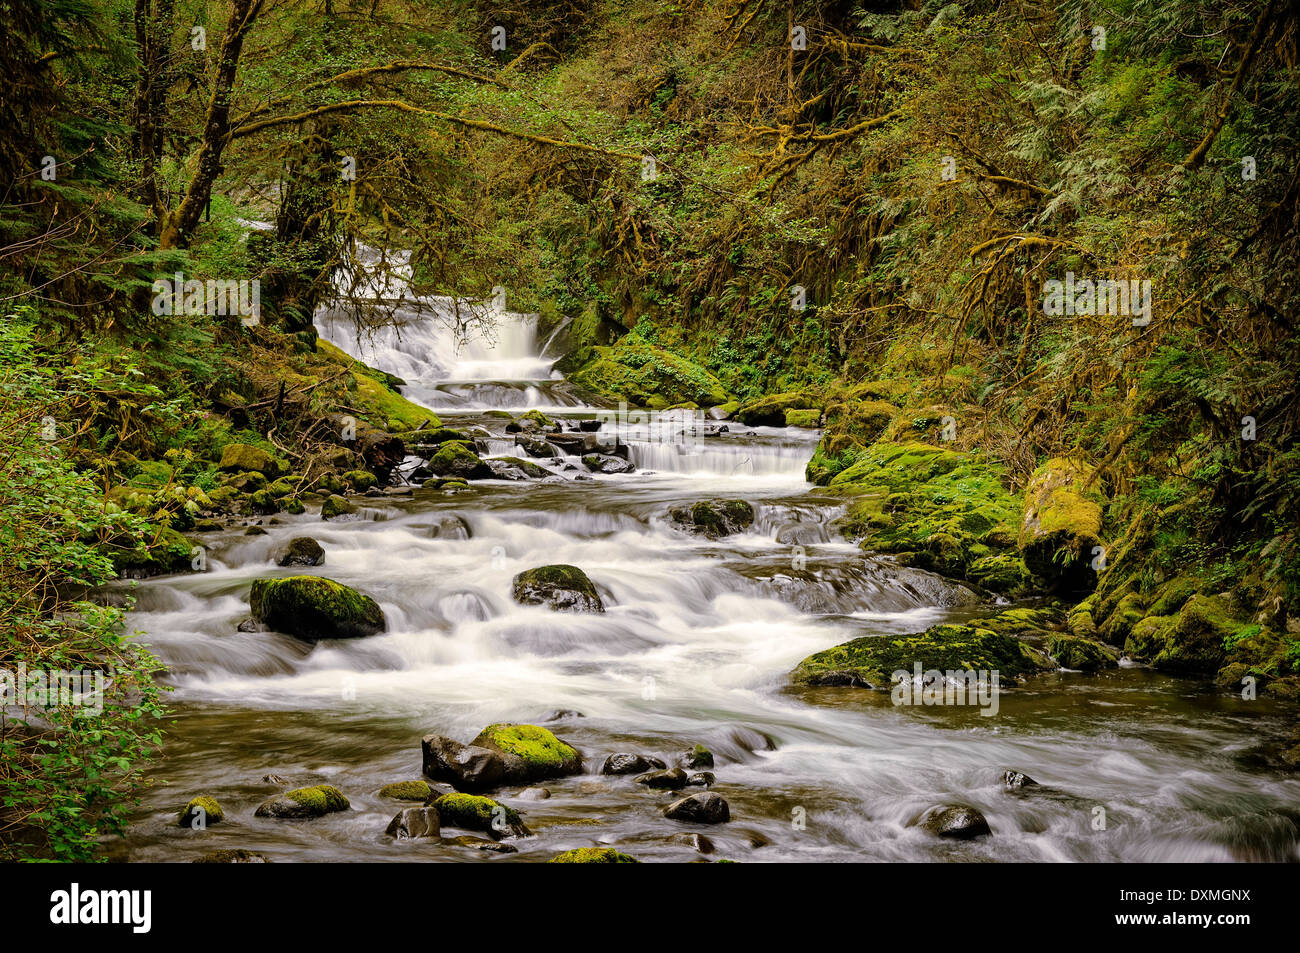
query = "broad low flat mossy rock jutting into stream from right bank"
xmin=793 ymin=624 xmax=1053 ymax=689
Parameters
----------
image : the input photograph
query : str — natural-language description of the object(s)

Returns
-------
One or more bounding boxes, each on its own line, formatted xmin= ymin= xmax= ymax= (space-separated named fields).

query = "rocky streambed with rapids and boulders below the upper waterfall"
xmin=113 ymin=408 xmax=1300 ymax=862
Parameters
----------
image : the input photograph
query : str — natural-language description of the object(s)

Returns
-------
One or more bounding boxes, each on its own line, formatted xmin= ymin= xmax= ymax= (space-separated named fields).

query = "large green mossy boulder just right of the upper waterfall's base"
xmin=569 ymin=334 xmax=729 ymax=408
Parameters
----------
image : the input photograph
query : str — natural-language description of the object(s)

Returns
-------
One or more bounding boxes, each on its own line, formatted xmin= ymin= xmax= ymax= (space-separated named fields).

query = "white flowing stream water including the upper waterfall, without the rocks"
xmin=114 ymin=291 xmax=1300 ymax=863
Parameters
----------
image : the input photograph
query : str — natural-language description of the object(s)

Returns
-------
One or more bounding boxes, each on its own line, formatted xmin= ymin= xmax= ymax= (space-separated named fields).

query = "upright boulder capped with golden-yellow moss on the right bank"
xmin=1019 ymin=458 xmax=1105 ymax=592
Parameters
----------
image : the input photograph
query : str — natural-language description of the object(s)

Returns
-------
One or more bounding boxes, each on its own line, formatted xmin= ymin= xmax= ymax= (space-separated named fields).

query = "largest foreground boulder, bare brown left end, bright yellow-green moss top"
xmin=421 ymin=723 xmax=582 ymax=792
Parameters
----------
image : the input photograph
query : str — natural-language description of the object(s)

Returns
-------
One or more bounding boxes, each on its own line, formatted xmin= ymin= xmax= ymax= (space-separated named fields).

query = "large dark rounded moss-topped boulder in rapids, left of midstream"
xmin=248 ymin=576 xmax=387 ymax=641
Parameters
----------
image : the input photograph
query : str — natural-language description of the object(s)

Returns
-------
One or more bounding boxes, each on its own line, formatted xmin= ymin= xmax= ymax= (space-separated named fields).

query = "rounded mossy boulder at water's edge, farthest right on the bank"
xmin=1125 ymin=595 xmax=1232 ymax=673
